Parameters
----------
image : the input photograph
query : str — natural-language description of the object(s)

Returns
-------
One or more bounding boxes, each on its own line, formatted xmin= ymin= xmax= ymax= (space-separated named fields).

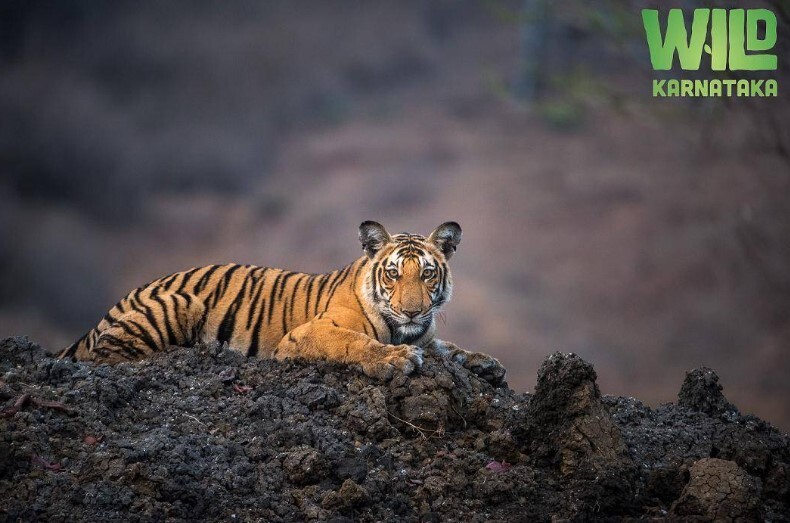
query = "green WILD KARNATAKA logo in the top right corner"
xmin=642 ymin=9 xmax=779 ymax=96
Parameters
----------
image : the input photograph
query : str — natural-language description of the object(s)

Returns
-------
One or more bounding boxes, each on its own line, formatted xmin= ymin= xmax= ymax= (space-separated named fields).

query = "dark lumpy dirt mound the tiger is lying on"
xmin=0 ymin=338 xmax=790 ymax=522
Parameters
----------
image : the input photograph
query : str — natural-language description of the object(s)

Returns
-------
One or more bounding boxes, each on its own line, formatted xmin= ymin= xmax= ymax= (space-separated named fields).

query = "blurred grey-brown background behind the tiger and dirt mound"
xmin=0 ymin=0 xmax=790 ymax=430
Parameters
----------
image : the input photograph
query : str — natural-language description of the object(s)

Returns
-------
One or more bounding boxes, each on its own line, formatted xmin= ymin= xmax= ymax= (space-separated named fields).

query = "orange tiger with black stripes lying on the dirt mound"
xmin=58 ymin=221 xmax=505 ymax=383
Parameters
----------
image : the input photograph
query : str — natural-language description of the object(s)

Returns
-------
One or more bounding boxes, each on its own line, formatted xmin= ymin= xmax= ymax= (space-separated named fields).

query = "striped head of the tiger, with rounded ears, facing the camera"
xmin=359 ymin=221 xmax=461 ymax=343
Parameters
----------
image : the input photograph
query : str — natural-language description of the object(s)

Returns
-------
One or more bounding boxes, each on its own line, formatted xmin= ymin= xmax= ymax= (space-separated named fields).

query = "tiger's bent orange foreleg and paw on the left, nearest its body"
xmin=272 ymin=320 xmax=422 ymax=380
